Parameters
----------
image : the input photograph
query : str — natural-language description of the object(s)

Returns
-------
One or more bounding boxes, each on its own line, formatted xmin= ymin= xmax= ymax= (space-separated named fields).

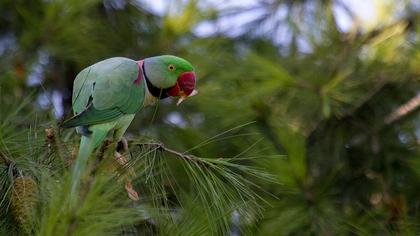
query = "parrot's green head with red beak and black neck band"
xmin=143 ymin=55 xmax=198 ymax=105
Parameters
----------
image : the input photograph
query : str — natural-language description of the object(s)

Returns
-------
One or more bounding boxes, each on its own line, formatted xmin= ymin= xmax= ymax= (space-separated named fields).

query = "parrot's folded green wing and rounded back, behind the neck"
xmin=61 ymin=57 xmax=145 ymax=127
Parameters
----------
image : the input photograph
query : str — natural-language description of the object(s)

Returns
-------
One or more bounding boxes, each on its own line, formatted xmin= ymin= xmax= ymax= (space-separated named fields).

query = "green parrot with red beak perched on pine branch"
xmin=61 ymin=55 xmax=197 ymax=201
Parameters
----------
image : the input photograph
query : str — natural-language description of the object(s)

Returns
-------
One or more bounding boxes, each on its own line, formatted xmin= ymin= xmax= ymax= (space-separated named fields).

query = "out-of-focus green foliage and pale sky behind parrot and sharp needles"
xmin=0 ymin=0 xmax=420 ymax=235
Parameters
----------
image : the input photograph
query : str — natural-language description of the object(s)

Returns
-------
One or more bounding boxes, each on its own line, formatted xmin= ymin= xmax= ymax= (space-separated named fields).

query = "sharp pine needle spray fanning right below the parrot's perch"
xmin=125 ymin=138 xmax=277 ymax=235
